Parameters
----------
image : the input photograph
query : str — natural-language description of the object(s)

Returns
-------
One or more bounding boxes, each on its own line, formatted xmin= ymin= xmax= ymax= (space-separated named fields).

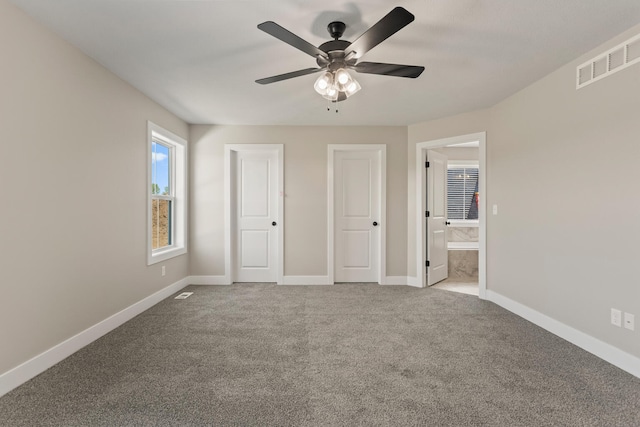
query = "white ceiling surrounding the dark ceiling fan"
xmin=11 ymin=0 xmax=640 ymax=126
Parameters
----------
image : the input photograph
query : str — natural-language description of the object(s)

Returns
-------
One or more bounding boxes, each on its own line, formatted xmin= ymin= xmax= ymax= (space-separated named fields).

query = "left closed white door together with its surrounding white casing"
xmin=225 ymin=144 xmax=283 ymax=283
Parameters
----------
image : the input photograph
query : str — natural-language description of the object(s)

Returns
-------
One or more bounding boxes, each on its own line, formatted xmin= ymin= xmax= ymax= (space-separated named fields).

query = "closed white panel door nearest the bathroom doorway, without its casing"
xmin=333 ymin=150 xmax=383 ymax=282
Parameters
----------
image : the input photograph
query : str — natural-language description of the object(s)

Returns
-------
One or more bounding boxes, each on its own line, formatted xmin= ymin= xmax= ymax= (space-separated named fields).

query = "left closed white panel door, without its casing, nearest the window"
xmin=234 ymin=150 xmax=281 ymax=282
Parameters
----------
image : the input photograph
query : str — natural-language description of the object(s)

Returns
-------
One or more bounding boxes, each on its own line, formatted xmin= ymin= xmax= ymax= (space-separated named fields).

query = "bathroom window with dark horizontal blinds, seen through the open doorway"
xmin=447 ymin=164 xmax=479 ymax=221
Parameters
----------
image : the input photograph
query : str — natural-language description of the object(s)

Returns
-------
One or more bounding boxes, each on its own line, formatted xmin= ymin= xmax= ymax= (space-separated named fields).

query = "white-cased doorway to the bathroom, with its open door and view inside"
xmin=416 ymin=132 xmax=486 ymax=298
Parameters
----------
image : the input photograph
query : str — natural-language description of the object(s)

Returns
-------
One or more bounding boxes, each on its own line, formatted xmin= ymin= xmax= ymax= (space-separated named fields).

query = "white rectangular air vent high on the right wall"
xmin=576 ymin=34 xmax=640 ymax=89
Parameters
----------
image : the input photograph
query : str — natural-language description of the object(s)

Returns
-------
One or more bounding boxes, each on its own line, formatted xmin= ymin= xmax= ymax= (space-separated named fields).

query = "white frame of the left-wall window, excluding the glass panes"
xmin=146 ymin=122 xmax=188 ymax=265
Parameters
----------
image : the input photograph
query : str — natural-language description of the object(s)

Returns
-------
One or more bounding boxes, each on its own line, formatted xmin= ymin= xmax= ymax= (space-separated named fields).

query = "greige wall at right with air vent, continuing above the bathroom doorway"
xmin=408 ymin=26 xmax=640 ymax=357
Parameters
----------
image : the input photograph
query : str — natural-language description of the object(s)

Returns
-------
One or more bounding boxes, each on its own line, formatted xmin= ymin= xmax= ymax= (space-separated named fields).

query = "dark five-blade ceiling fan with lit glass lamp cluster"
xmin=256 ymin=7 xmax=424 ymax=102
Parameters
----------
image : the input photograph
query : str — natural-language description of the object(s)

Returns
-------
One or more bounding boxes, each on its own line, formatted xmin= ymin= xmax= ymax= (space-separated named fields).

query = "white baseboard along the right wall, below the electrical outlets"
xmin=486 ymin=290 xmax=640 ymax=378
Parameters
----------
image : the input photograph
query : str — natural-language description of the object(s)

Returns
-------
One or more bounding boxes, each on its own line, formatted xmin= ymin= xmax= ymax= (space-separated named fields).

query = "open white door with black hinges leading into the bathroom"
xmin=426 ymin=150 xmax=449 ymax=286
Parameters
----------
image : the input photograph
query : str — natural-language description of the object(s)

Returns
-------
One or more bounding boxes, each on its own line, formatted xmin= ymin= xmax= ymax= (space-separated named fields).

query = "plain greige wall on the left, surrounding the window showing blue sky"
xmin=0 ymin=1 xmax=188 ymax=373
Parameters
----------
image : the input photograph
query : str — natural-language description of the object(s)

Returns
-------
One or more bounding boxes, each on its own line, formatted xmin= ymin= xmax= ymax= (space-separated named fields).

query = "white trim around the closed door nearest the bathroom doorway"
xmin=327 ymin=144 xmax=387 ymax=285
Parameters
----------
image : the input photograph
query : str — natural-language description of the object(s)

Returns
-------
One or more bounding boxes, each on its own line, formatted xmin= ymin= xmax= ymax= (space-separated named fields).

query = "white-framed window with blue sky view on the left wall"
xmin=147 ymin=122 xmax=187 ymax=265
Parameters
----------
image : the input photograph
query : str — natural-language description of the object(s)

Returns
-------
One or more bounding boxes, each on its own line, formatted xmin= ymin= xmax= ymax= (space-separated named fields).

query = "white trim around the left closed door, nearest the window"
xmin=224 ymin=144 xmax=284 ymax=284
